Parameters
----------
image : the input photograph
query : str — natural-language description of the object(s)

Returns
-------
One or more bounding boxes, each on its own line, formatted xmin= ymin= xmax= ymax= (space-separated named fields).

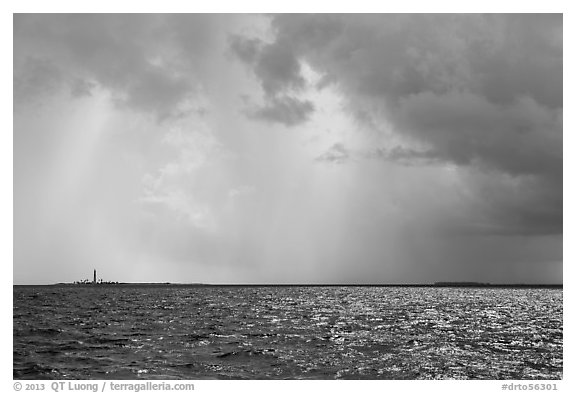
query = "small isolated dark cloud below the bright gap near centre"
xmin=247 ymin=96 xmax=314 ymax=126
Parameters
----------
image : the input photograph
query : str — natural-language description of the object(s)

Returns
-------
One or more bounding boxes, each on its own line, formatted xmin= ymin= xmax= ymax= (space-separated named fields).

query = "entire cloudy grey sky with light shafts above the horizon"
xmin=13 ymin=14 xmax=563 ymax=284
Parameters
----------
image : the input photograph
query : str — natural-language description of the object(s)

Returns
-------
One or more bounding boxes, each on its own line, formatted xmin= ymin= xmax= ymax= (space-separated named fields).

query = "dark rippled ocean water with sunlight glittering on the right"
xmin=13 ymin=286 xmax=563 ymax=379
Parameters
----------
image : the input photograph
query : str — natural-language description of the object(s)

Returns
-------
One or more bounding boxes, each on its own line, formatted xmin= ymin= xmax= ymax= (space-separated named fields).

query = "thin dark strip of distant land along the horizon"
xmin=14 ymin=281 xmax=563 ymax=289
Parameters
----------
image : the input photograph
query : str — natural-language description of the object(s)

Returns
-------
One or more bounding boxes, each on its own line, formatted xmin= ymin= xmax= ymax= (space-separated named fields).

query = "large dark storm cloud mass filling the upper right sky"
xmin=270 ymin=15 xmax=562 ymax=165
